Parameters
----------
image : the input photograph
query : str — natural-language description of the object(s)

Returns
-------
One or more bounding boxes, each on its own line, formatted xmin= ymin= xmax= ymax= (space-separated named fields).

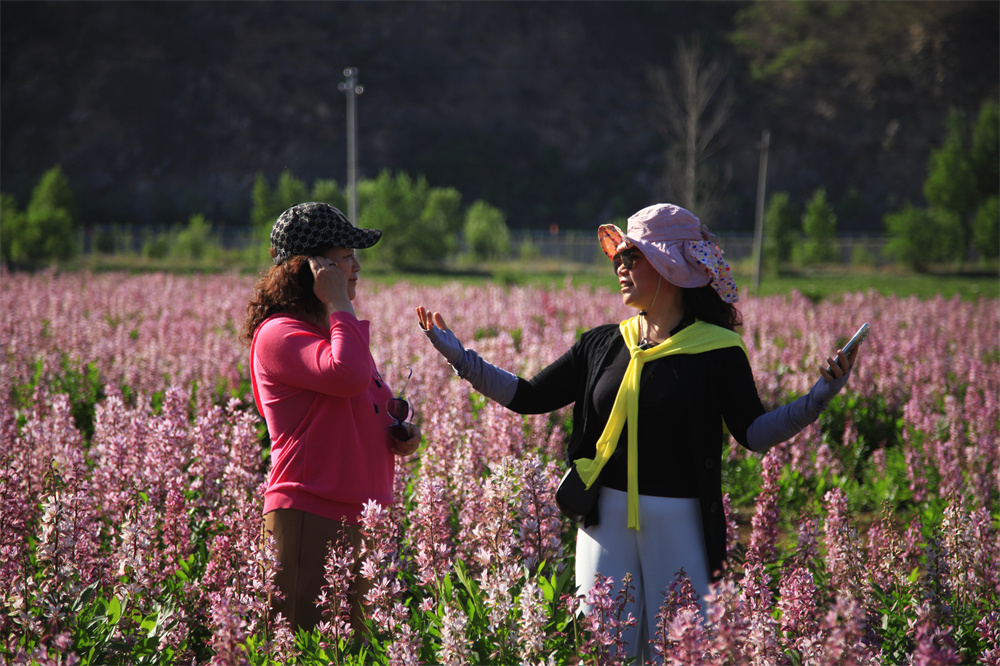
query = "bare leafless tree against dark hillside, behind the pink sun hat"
xmin=648 ymin=38 xmax=735 ymax=220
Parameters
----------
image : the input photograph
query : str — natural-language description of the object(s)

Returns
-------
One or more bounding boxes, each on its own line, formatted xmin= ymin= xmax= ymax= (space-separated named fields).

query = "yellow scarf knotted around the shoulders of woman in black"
xmin=574 ymin=315 xmax=747 ymax=530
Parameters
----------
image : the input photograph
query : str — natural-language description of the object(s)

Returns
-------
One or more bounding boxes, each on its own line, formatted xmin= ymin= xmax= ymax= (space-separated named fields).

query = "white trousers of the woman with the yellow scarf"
xmin=576 ymin=488 xmax=711 ymax=661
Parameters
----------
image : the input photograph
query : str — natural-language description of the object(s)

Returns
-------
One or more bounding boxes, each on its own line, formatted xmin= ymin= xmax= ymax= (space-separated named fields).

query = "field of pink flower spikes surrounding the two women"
xmin=0 ymin=272 xmax=1000 ymax=665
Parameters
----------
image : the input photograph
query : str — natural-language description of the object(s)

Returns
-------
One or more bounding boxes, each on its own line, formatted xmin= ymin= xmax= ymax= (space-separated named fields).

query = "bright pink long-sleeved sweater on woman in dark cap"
xmin=250 ymin=313 xmax=395 ymax=523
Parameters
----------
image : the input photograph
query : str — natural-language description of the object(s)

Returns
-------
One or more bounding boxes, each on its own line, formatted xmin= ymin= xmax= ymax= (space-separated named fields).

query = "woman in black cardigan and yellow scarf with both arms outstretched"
xmin=417 ymin=204 xmax=857 ymax=657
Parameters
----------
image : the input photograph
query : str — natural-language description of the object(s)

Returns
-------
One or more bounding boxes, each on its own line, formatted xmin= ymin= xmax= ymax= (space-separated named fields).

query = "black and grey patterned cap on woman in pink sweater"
xmin=271 ymin=201 xmax=382 ymax=265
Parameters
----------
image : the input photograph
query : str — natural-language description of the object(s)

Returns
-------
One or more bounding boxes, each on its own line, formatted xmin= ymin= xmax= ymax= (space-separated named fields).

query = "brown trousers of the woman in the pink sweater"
xmin=264 ymin=509 xmax=371 ymax=631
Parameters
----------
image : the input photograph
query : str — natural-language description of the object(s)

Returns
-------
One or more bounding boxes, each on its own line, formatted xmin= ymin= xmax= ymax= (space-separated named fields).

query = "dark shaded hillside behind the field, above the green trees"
xmin=0 ymin=1 xmax=1000 ymax=232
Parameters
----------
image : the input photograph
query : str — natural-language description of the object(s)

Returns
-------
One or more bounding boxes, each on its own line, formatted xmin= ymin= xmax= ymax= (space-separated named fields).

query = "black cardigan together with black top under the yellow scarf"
xmin=508 ymin=324 xmax=766 ymax=572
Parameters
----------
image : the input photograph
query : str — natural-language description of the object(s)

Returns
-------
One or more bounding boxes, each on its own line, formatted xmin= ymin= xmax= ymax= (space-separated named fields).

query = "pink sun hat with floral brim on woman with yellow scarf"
xmin=597 ymin=204 xmax=739 ymax=303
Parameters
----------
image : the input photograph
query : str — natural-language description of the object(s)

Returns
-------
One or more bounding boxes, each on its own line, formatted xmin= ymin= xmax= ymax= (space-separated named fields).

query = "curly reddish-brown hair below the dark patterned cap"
xmin=240 ymin=253 xmax=326 ymax=347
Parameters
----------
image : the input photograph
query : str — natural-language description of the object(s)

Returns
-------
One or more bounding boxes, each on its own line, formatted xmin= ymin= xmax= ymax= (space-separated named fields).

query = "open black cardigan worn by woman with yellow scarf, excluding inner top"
xmin=507 ymin=324 xmax=765 ymax=578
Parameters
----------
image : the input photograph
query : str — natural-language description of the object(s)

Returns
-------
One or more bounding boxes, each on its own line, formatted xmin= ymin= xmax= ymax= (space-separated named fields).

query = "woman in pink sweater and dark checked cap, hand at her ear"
xmin=242 ymin=203 xmax=420 ymax=630
